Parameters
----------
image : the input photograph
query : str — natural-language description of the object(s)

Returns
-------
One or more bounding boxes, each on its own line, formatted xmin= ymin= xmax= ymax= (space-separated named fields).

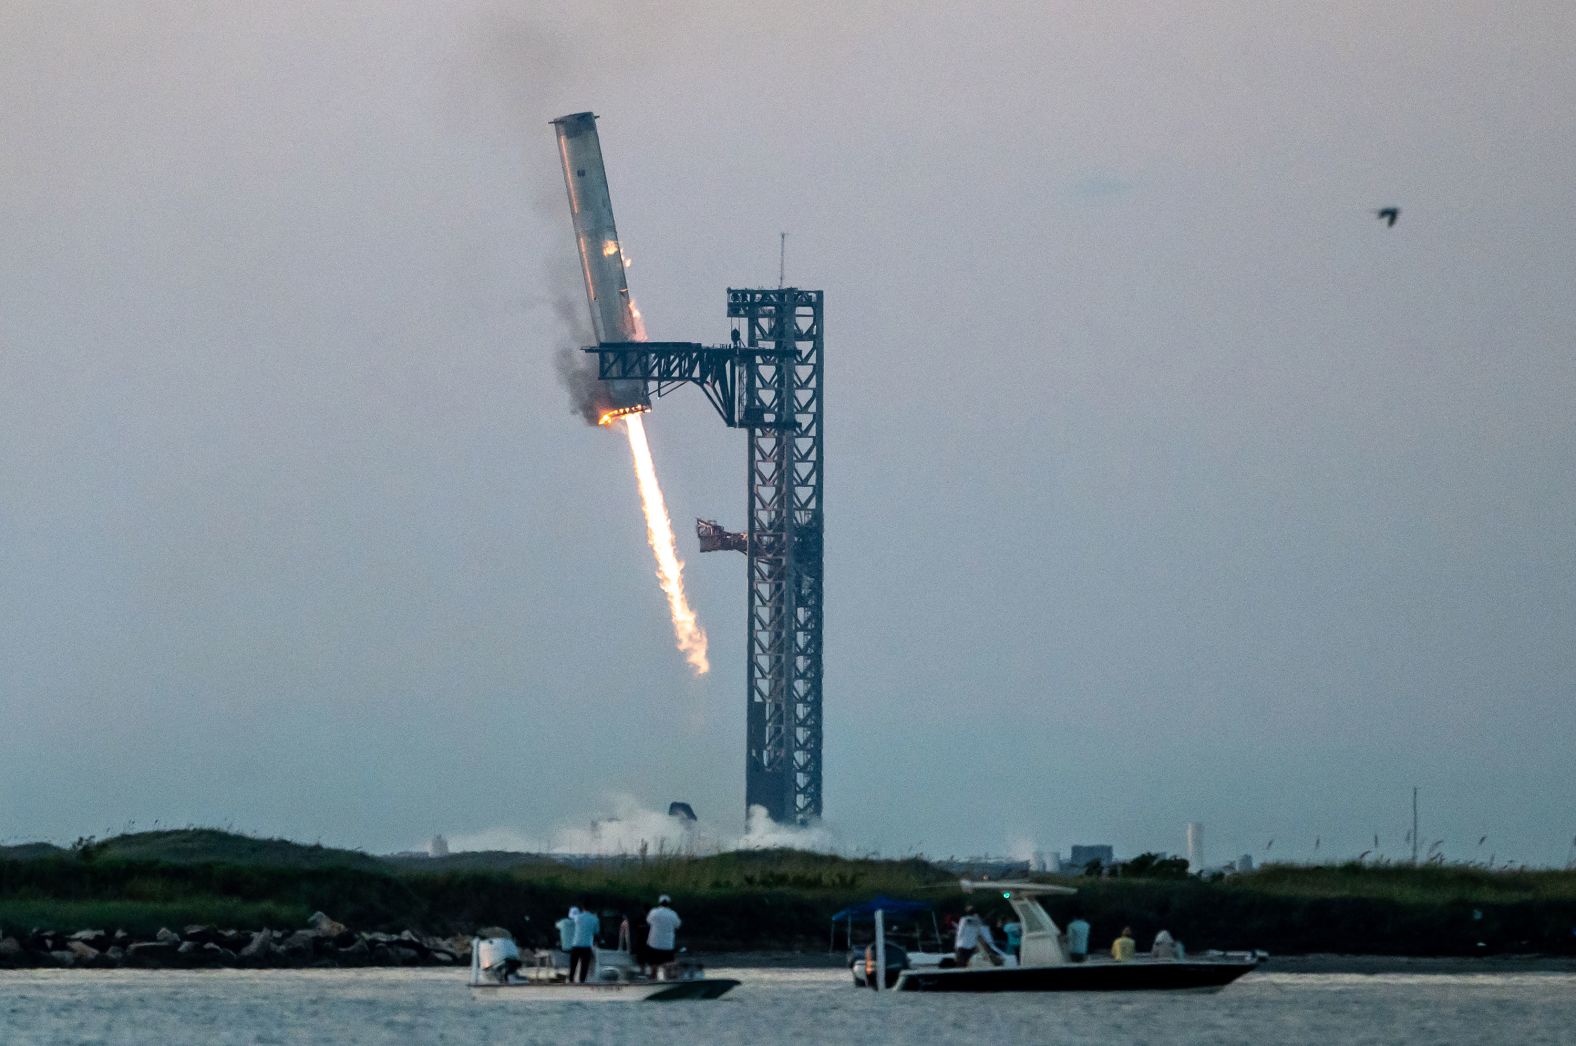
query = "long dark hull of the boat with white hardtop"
xmin=895 ymin=959 xmax=1258 ymax=992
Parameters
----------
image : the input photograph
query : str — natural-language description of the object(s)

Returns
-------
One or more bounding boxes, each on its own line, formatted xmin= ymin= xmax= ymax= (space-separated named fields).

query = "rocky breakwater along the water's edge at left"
xmin=0 ymin=912 xmax=471 ymax=969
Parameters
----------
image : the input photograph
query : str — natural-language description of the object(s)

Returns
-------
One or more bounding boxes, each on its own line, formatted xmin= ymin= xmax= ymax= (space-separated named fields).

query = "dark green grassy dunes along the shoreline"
xmin=0 ymin=830 xmax=1576 ymax=956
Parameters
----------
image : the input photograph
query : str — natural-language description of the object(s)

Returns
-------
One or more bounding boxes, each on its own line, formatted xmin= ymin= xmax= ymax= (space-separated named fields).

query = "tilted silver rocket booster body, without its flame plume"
xmin=553 ymin=112 xmax=651 ymax=424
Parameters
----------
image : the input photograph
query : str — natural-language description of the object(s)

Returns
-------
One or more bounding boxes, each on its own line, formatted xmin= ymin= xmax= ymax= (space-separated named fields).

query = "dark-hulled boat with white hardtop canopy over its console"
xmin=854 ymin=879 xmax=1261 ymax=992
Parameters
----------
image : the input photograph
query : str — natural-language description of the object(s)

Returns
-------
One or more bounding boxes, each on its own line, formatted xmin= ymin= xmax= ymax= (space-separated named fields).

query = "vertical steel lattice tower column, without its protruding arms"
xmin=728 ymin=287 xmax=823 ymax=824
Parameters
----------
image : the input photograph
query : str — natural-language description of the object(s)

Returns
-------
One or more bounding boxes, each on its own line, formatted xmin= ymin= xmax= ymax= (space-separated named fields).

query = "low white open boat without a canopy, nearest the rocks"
xmin=470 ymin=937 xmax=739 ymax=1002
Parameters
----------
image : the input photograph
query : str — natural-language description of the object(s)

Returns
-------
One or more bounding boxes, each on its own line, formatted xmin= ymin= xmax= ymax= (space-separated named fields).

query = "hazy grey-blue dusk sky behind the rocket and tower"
xmin=0 ymin=0 xmax=1576 ymax=863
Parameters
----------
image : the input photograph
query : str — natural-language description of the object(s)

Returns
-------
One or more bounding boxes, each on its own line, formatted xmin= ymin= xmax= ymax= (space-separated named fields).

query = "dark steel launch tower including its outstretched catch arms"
xmin=585 ymin=287 xmax=823 ymax=824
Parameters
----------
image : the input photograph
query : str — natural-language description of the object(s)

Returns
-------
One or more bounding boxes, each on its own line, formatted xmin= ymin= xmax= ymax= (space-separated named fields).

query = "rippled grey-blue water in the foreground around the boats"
xmin=0 ymin=969 xmax=1576 ymax=1046
